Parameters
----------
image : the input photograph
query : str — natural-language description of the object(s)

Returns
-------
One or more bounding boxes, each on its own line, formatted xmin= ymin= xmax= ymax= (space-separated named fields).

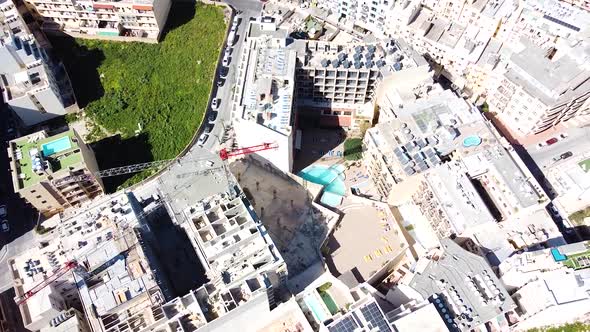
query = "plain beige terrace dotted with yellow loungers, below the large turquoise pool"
xmin=326 ymin=206 xmax=408 ymax=280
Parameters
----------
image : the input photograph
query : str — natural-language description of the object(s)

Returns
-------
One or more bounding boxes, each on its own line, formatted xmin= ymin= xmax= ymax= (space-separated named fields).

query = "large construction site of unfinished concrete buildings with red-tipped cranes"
xmin=9 ymin=147 xmax=296 ymax=332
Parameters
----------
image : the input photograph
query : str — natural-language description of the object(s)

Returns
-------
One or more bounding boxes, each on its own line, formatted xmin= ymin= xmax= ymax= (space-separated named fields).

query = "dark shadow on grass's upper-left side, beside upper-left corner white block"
xmin=47 ymin=32 xmax=105 ymax=108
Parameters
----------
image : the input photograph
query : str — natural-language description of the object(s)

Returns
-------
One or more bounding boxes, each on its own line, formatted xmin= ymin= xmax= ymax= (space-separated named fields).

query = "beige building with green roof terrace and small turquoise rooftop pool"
xmin=8 ymin=130 xmax=103 ymax=215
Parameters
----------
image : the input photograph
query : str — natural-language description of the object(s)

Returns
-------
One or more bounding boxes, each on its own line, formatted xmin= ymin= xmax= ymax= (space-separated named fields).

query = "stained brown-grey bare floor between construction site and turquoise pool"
xmin=230 ymin=158 xmax=327 ymax=275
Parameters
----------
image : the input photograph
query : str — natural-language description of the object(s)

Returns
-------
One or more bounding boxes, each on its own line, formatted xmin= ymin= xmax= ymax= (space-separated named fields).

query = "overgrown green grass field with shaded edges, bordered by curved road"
xmin=52 ymin=3 xmax=226 ymax=186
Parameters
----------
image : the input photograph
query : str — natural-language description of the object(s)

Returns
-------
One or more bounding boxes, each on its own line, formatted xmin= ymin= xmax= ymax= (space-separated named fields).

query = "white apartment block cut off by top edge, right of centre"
xmin=317 ymin=0 xmax=395 ymax=37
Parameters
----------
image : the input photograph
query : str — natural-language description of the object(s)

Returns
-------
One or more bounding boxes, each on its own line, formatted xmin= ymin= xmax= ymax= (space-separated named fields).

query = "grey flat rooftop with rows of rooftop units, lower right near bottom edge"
xmin=409 ymin=238 xmax=514 ymax=330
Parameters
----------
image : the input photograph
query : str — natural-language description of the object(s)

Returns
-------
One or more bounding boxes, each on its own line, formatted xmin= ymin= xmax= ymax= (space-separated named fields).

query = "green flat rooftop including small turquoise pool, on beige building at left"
xmin=10 ymin=130 xmax=83 ymax=189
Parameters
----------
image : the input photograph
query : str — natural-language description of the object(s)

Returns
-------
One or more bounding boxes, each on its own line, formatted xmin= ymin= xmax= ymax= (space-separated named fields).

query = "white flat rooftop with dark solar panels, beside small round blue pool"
xmin=367 ymin=90 xmax=495 ymax=179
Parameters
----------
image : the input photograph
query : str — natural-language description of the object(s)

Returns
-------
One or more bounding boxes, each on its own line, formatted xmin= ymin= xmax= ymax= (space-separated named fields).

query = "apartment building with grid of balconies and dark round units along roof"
xmin=296 ymin=40 xmax=430 ymax=128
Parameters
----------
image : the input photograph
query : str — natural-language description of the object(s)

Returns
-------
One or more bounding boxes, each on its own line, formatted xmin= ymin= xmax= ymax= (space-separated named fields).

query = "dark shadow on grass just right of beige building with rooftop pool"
xmin=91 ymin=132 xmax=154 ymax=193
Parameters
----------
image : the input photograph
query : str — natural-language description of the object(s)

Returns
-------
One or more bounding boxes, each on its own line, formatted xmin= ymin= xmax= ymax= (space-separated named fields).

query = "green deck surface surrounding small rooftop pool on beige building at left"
xmin=15 ymin=130 xmax=82 ymax=189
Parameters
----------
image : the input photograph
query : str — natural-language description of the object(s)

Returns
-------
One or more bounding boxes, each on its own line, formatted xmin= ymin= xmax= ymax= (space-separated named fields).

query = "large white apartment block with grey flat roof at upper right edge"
xmin=488 ymin=41 xmax=590 ymax=136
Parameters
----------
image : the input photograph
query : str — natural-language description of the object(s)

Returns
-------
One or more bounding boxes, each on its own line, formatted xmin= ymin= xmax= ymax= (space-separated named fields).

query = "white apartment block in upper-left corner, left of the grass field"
xmin=0 ymin=0 xmax=77 ymax=127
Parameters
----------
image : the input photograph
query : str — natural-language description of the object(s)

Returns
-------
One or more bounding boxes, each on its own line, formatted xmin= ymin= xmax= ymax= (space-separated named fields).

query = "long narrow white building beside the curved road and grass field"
xmin=233 ymin=21 xmax=297 ymax=172
